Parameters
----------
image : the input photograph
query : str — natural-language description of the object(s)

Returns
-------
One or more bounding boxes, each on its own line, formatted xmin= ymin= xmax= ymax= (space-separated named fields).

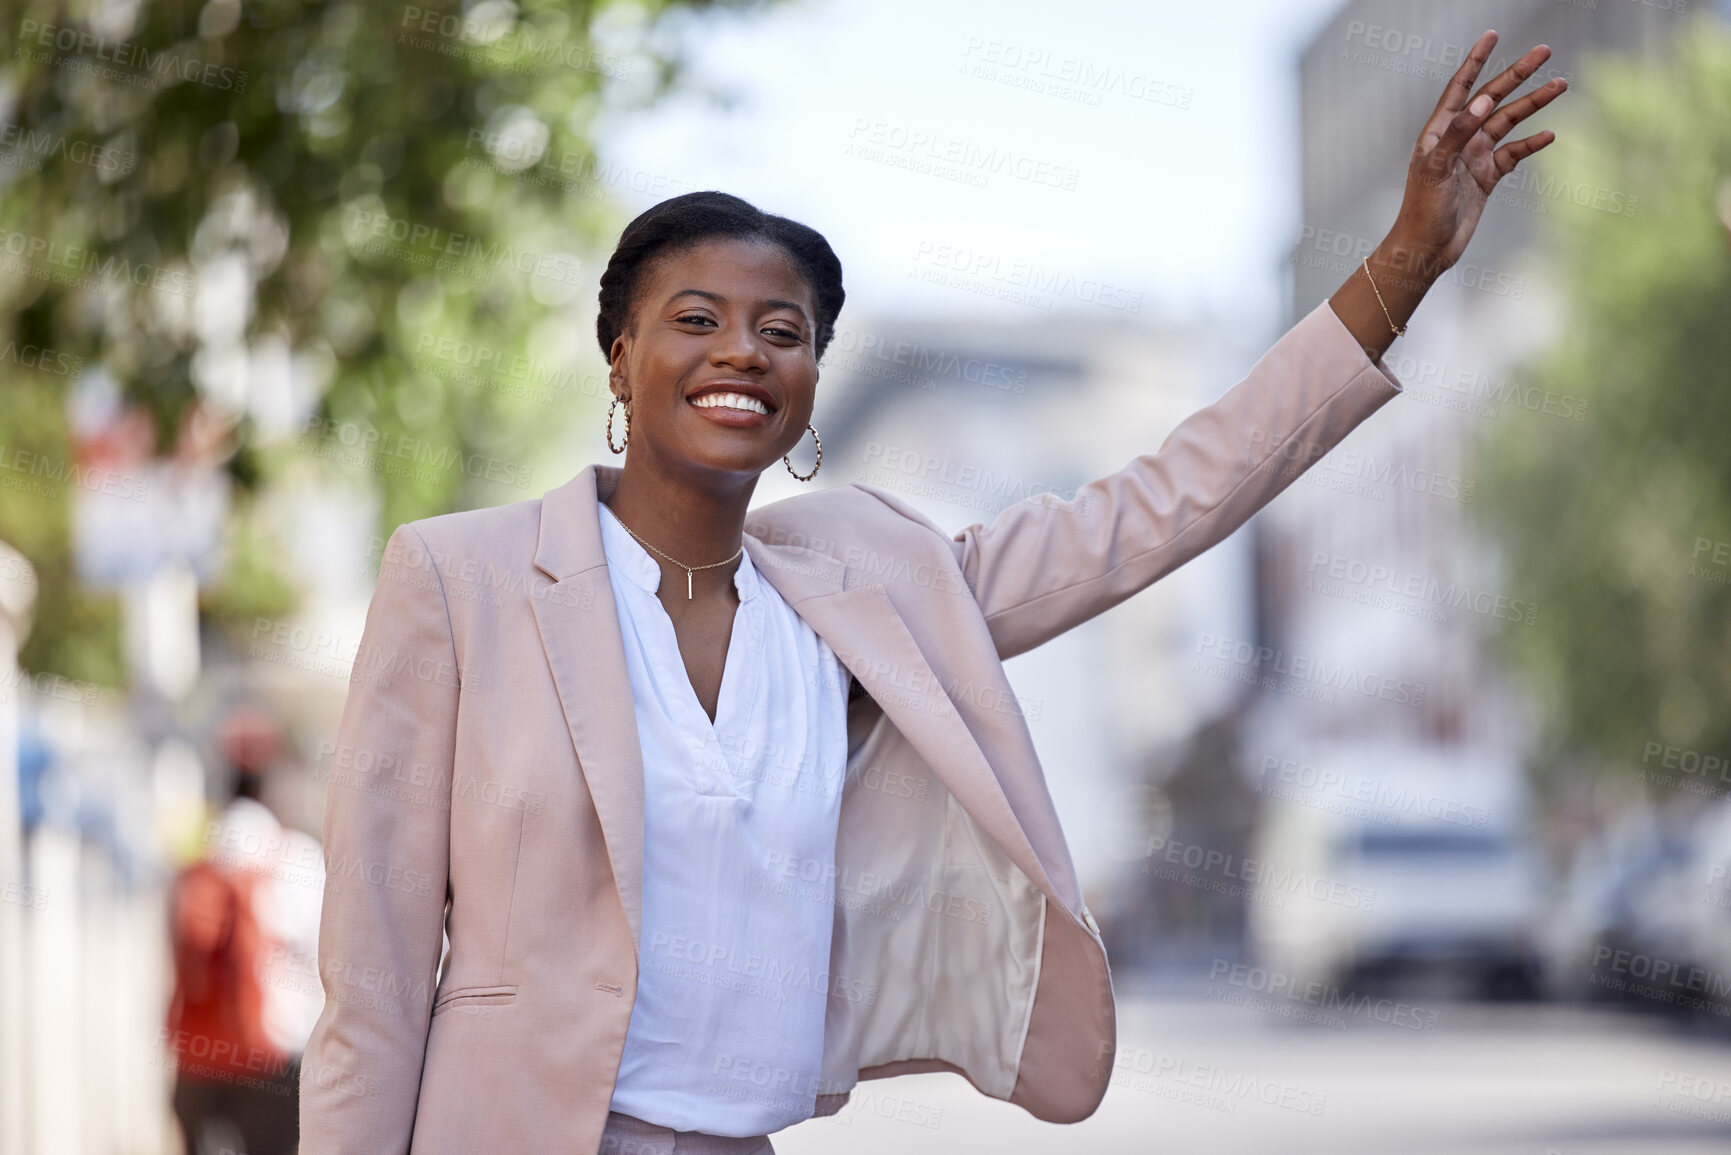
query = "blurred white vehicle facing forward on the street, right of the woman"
xmin=1250 ymin=745 xmax=1542 ymax=997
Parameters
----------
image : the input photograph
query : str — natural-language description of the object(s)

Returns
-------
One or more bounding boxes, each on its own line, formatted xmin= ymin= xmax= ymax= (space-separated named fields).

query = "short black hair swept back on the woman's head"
xmin=595 ymin=190 xmax=848 ymax=360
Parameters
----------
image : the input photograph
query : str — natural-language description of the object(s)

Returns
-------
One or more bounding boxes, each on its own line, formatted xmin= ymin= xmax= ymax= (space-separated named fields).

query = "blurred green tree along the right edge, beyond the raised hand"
xmin=1482 ymin=16 xmax=1731 ymax=786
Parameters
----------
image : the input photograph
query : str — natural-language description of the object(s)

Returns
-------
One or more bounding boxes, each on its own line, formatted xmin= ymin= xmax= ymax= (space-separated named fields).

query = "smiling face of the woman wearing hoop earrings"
xmin=609 ymin=237 xmax=817 ymax=481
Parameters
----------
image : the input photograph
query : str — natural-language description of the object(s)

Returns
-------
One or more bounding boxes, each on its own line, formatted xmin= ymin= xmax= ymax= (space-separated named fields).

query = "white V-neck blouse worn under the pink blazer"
xmin=601 ymin=504 xmax=846 ymax=1136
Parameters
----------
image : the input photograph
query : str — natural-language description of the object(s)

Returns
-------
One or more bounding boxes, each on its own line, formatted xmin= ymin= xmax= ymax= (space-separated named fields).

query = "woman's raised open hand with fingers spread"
xmin=1392 ymin=31 xmax=1568 ymax=270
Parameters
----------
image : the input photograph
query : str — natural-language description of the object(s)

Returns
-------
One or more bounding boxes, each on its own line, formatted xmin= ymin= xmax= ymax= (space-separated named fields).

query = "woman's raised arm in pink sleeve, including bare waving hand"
xmin=954 ymin=31 xmax=1565 ymax=658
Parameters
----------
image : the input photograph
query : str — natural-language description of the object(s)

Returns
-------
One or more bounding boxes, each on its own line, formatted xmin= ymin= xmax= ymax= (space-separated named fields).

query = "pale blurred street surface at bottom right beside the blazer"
xmin=775 ymin=997 xmax=1731 ymax=1155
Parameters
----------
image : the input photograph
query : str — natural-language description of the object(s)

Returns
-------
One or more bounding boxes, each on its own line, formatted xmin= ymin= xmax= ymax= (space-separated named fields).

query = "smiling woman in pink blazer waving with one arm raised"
xmin=301 ymin=33 xmax=1563 ymax=1155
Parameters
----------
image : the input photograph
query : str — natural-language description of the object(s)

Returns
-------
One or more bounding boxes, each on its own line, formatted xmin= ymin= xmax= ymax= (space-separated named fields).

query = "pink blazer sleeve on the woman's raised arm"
xmin=954 ymin=301 xmax=1400 ymax=658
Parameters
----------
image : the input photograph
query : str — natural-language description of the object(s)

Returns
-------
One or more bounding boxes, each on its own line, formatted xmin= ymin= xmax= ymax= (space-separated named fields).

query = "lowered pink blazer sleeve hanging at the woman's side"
xmin=299 ymin=525 xmax=457 ymax=1155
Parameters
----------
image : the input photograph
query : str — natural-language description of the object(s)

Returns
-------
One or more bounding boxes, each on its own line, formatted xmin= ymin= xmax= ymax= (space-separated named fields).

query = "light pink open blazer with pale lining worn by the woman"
xmin=301 ymin=303 xmax=1400 ymax=1155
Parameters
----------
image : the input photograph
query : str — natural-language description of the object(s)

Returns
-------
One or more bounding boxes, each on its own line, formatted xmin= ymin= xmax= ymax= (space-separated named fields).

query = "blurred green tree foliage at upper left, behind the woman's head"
xmin=0 ymin=0 xmax=753 ymax=684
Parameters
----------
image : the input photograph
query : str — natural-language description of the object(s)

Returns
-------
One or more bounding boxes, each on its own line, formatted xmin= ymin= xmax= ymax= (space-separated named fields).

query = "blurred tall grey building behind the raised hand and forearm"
xmin=1245 ymin=0 xmax=1684 ymax=983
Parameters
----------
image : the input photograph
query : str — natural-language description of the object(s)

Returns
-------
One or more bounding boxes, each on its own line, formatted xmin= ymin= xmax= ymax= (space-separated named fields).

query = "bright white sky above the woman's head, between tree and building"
xmin=599 ymin=0 xmax=1340 ymax=327
